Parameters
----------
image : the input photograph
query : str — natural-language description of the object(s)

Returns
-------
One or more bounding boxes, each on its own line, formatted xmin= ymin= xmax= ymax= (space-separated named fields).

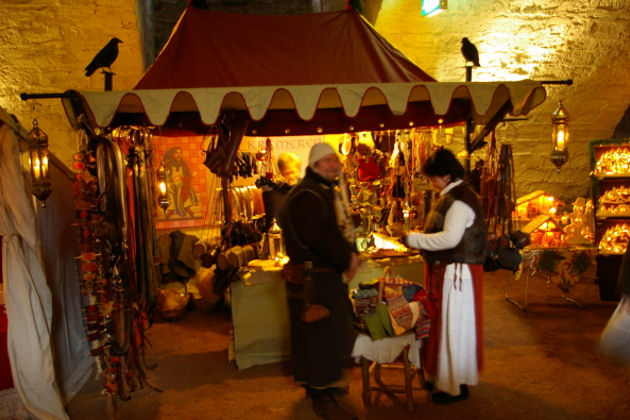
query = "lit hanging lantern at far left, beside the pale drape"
xmin=27 ymin=119 xmax=52 ymax=207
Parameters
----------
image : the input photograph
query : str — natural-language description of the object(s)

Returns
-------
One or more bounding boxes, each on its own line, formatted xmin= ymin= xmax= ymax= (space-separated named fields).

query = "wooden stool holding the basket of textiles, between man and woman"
xmin=361 ymin=347 xmax=424 ymax=411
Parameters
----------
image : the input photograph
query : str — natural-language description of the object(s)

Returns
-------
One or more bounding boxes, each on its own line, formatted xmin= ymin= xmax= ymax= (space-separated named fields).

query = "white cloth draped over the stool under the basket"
xmin=352 ymin=333 xmax=421 ymax=368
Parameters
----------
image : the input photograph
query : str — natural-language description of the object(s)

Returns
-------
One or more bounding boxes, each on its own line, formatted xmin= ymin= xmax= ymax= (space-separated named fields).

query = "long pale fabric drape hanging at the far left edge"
xmin=0 ymin=124 xmax=68 ymax=419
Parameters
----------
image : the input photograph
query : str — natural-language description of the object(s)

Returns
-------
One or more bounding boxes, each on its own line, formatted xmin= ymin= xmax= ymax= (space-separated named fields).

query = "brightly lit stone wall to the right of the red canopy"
xmin=368 ymin=0 xmax=630 ymax=200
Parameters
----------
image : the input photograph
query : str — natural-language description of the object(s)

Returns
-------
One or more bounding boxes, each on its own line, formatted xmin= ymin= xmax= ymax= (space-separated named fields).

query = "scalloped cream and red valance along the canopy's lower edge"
xmin=71 ymin=81 xmax=546 ymax=135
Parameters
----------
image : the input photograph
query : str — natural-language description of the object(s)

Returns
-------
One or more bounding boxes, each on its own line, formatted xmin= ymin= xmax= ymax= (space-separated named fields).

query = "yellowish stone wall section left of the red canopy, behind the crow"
xmin=0 ymin=0 xmax=143 ymax=166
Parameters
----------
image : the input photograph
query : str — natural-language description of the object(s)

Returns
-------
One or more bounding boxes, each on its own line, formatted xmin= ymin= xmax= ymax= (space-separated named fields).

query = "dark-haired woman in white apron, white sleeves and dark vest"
xmin=403 ymin=149 xmax=487 ymax=404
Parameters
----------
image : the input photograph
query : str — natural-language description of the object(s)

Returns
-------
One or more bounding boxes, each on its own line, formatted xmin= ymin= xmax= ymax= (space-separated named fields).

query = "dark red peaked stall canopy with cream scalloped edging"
xmin=64 ymin=5 xmax=546 ymax=140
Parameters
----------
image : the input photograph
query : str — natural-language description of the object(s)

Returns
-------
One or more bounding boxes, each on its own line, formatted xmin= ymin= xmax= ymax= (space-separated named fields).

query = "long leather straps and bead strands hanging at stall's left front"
xmin=73 ymin=127 xmax=163 ymax=400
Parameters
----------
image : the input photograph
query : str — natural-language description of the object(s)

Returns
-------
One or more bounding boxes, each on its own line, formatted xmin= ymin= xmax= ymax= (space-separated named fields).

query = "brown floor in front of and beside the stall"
xmin=67 ymin=272 xmax=630 ymax=420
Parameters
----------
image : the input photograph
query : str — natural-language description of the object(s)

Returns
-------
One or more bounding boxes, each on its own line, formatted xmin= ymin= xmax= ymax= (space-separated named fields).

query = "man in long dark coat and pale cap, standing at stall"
xmin=280 ymin=143 xmax=359 ymax=419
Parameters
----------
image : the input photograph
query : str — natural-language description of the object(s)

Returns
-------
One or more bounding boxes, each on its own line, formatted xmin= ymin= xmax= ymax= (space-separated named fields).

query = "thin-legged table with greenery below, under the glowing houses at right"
xmin=505 ymin=247 xmax=597 ymax=311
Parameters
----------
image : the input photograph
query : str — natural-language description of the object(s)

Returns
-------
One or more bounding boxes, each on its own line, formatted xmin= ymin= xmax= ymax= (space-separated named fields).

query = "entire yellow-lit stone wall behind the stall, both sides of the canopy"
xmin=0 ymin=0 xmax=630 ymax=200
